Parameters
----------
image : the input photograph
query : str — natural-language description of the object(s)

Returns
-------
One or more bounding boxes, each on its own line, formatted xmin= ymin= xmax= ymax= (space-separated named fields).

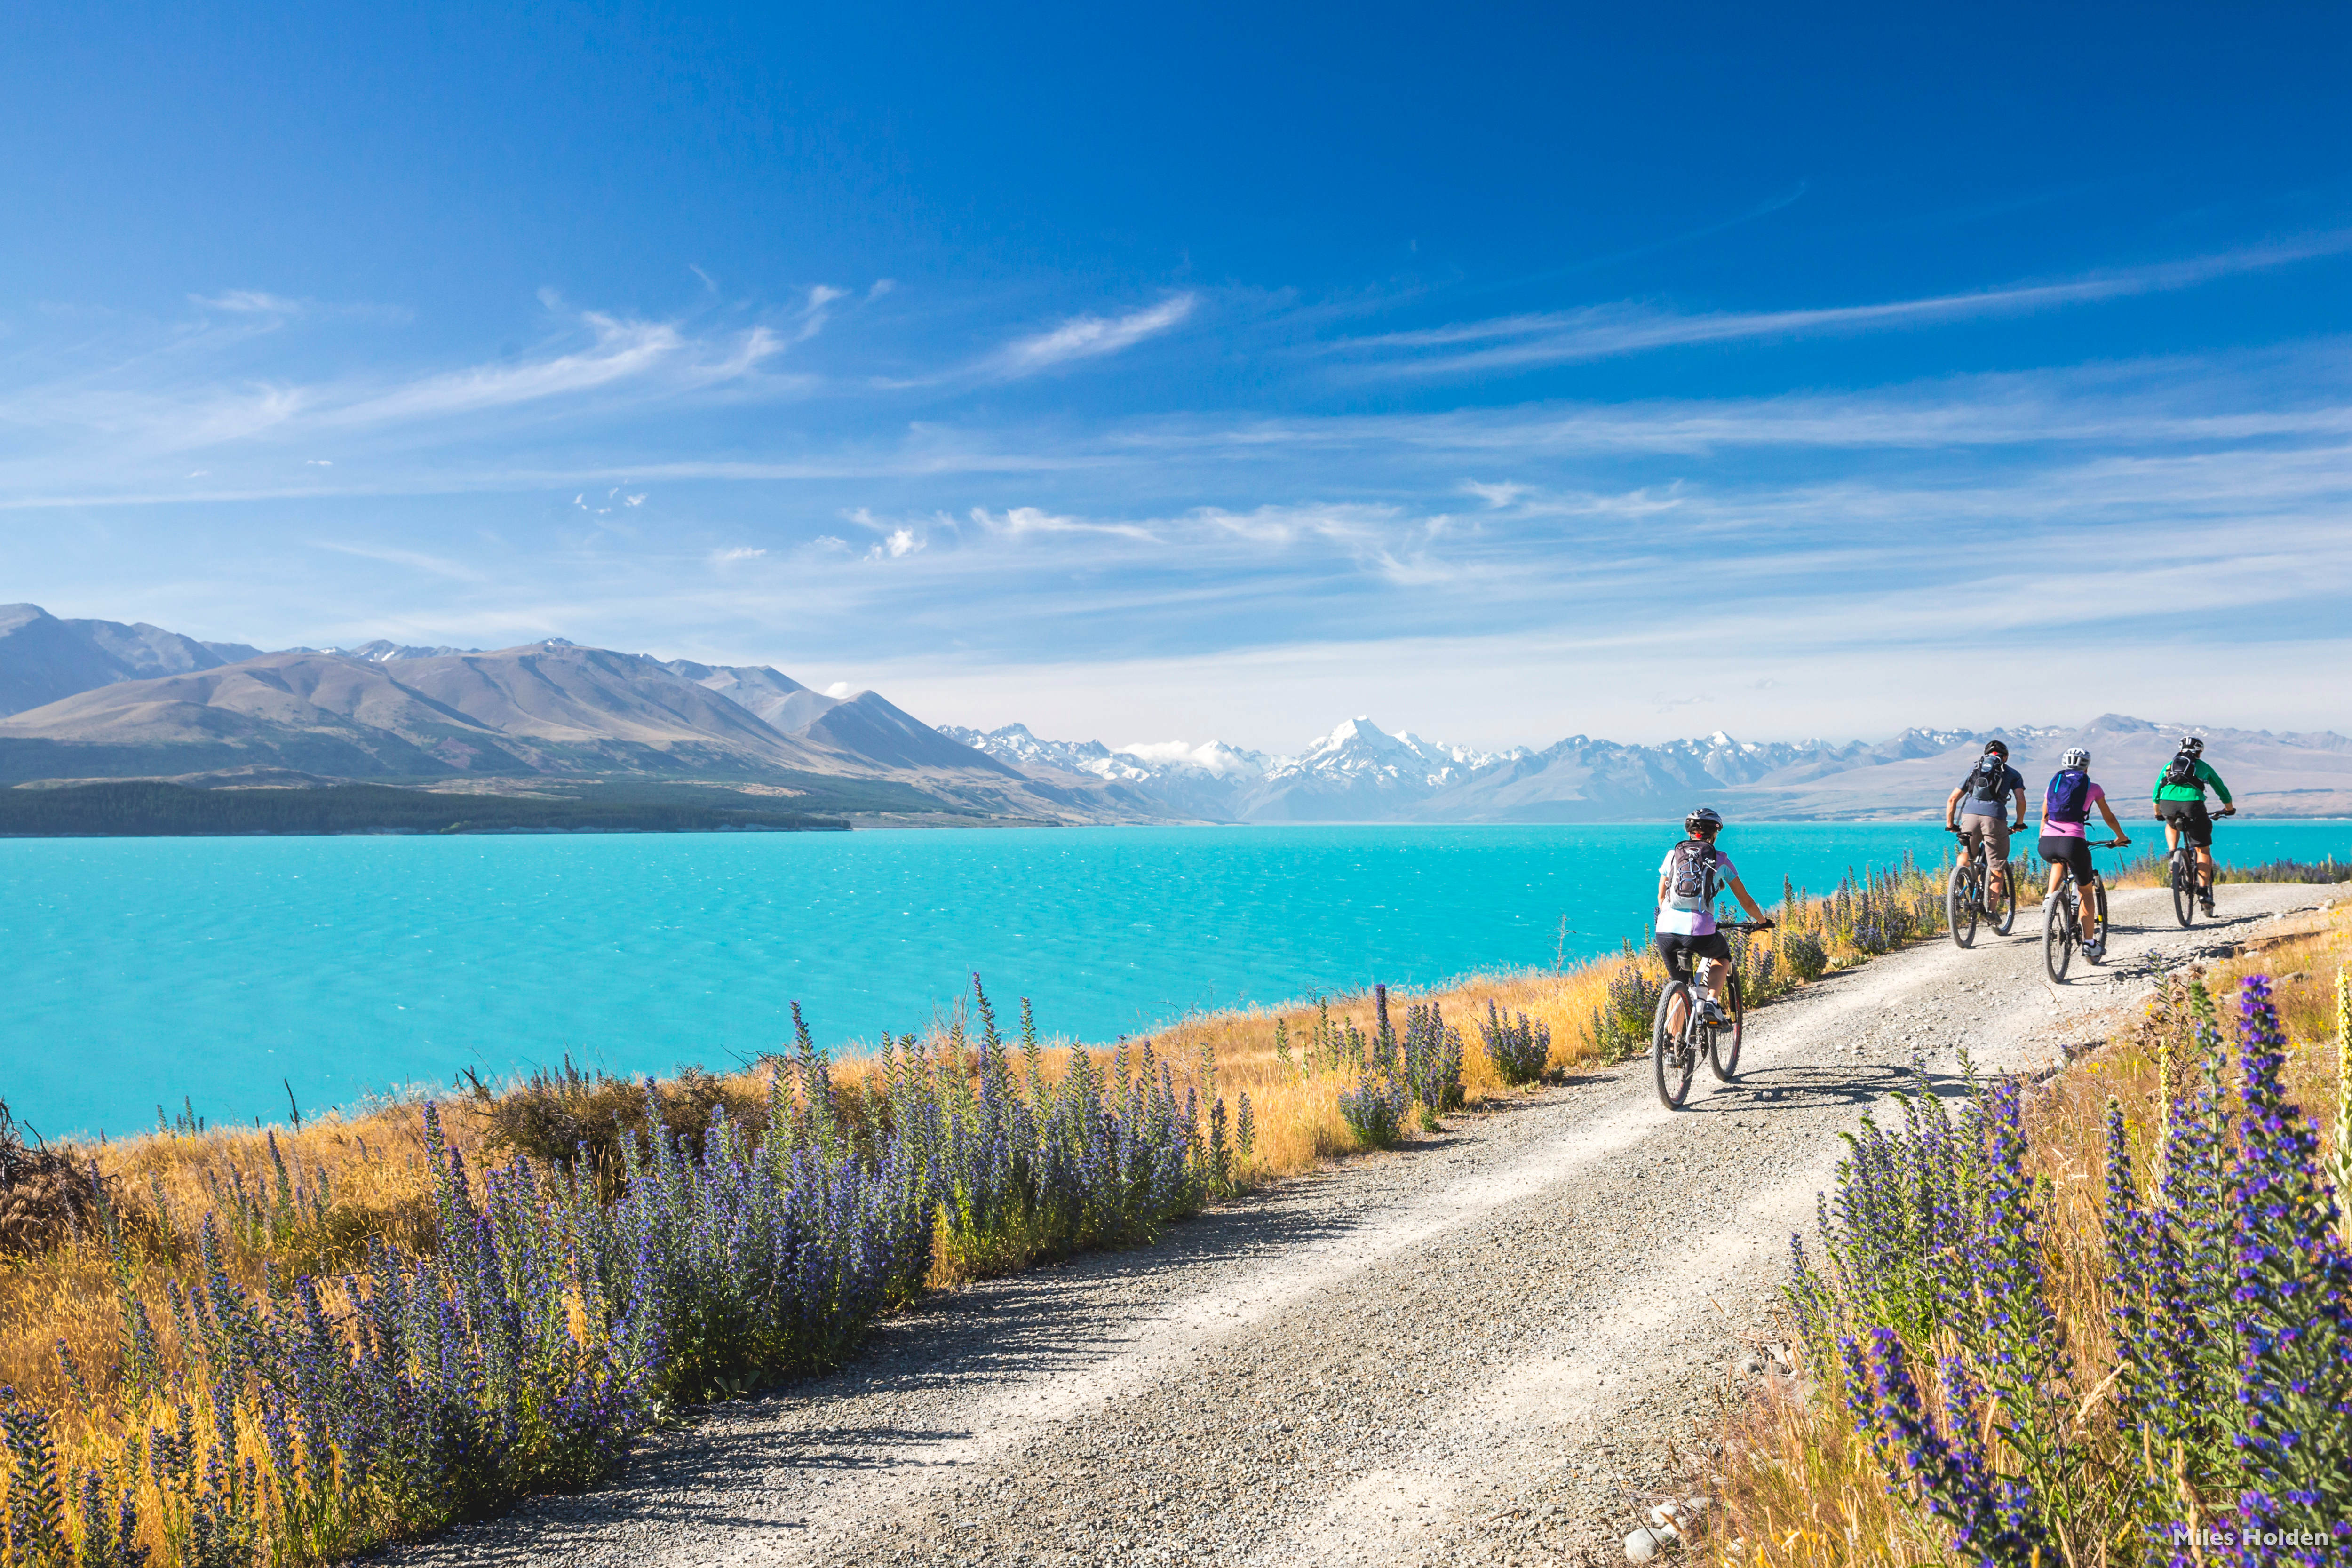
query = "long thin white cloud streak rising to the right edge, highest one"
xmin=1322 ymin=231 xmax=2352 ymax=376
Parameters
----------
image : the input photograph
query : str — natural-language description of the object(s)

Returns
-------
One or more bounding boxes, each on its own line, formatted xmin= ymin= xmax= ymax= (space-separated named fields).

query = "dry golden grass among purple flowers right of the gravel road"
xmin=1705 ymin=905 xmax=2352 ymax=1568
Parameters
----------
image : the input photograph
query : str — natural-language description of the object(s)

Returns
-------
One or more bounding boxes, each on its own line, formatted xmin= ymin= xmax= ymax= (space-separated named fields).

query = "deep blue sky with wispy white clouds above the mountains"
xmin=0 ymin=5 xmax=2352 ymax=750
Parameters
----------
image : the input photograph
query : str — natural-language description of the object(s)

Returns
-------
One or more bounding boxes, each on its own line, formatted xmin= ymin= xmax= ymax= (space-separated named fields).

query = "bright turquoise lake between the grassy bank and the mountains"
xmin=0 ymin=820 xmax=2352 ymax=1138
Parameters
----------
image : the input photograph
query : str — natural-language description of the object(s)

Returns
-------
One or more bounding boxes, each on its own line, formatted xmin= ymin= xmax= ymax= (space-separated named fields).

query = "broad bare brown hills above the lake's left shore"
xmin=0 ymin=639 xmax=1195 ymax=823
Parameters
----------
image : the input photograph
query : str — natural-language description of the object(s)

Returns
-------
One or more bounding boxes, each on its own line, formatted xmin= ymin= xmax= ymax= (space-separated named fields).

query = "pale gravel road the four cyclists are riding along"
xmin=383 ymin=884 xmax=2324 ymax=1568
